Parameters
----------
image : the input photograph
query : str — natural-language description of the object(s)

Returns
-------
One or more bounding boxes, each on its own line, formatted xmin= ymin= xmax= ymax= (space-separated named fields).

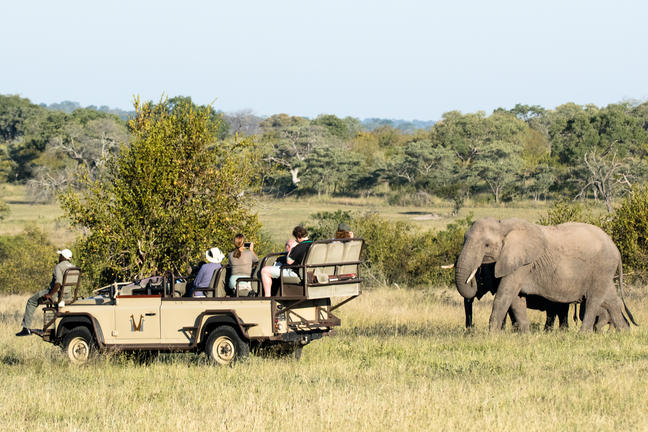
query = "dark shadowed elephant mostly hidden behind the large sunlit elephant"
xmin=464 ymin=263 xmax=569 ymax=332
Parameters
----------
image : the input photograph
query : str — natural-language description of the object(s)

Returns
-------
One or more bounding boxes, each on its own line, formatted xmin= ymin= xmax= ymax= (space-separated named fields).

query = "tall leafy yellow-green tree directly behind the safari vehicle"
xmin=61 ymin=100 xmax=259 ymax=283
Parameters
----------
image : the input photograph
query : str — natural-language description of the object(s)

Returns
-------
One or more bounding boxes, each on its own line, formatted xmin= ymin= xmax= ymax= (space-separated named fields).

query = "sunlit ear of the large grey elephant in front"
xmin=495 ymin=224 xmax=547 ymax=278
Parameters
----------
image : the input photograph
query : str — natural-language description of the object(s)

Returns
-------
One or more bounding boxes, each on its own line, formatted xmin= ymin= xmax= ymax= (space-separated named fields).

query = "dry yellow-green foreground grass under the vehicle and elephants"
xmin=0 ymin=288 xmax=648 ymax=431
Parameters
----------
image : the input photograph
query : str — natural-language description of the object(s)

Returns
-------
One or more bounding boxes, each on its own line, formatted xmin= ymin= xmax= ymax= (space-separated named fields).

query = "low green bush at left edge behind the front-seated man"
xmin=0 ymin=228 xmax=56 ymax=294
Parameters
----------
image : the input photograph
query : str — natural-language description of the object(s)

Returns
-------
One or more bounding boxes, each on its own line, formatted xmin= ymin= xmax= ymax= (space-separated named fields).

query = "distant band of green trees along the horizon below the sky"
xmin=0 ymin=96 xmax=648 ymax=209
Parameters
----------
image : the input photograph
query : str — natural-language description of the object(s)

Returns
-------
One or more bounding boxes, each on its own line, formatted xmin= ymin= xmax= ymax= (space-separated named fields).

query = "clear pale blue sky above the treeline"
xmin=0 ymin=0 xmax=648 ymax=120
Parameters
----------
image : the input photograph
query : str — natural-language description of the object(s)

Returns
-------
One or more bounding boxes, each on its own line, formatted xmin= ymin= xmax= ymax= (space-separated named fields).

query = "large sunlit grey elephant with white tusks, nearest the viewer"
xmin=455 ymin=218 xmax=636 ymax=331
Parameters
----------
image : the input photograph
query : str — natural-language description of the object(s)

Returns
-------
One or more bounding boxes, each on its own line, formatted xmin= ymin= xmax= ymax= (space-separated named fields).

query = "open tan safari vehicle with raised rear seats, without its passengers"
xmin=34 ymin=239 xmax=364 ymax=364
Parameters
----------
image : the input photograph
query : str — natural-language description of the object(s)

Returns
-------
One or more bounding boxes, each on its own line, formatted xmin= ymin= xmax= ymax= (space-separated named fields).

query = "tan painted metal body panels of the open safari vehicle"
xmin=56 ymin=295 xmax=330 ymax=347
